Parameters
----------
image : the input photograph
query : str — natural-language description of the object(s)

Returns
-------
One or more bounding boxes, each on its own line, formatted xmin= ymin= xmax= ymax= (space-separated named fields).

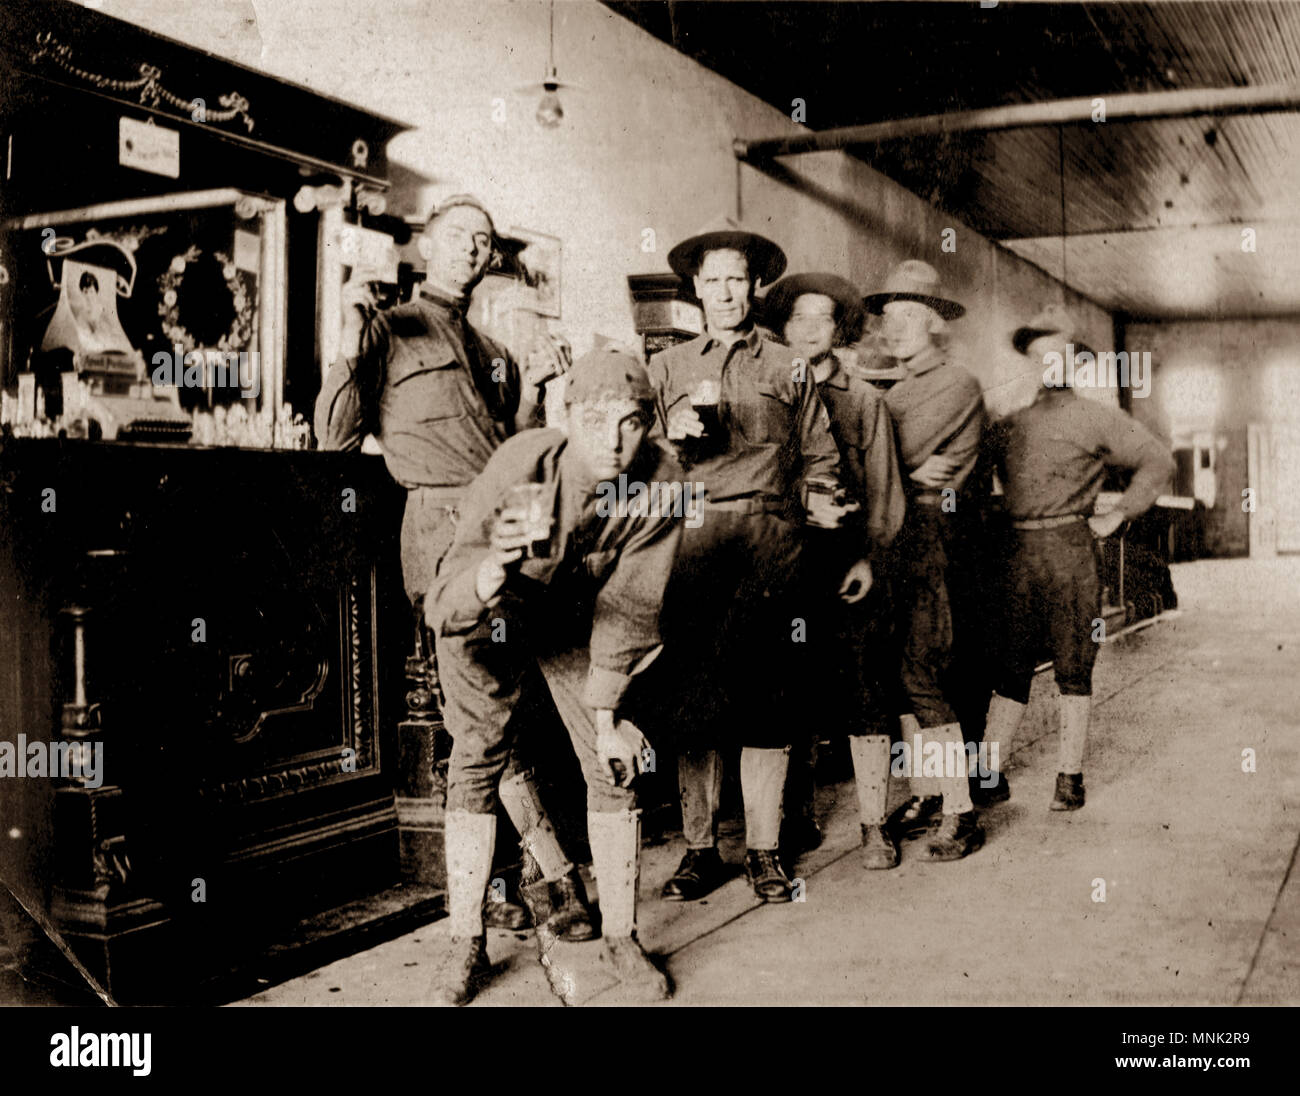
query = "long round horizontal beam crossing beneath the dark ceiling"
xmin=732 ymin=83 xmax=1300 ymax=160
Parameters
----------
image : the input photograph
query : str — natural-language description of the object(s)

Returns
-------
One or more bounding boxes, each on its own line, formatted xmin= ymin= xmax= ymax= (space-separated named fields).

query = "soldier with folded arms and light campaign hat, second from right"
xmin=865 ymin=260 xmax=984 ymax=861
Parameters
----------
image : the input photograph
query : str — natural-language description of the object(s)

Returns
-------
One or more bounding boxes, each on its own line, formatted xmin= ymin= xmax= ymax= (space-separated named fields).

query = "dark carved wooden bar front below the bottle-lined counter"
xmin=0 ymin=439 xmax=408 ymax=998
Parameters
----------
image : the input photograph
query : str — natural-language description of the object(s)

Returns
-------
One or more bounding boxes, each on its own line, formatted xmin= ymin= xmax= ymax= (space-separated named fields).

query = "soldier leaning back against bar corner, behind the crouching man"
xmin=316 ymin=194 xmax=595 ymax=940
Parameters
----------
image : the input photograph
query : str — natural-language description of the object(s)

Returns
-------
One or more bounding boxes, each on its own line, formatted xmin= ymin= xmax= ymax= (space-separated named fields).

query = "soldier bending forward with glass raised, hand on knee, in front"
xmin=425 ymin=347 xmax=681 ymax=1004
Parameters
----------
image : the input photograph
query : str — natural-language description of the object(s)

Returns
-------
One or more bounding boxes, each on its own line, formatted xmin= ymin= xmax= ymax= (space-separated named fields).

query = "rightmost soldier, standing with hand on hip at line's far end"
xmin=984 ymin=306 xmax=1174 ymax=810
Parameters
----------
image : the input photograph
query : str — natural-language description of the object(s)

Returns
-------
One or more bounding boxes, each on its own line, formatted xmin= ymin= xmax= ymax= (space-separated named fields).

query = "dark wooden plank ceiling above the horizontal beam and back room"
xmin=607 ymin=0 xmax=1300 ymax=319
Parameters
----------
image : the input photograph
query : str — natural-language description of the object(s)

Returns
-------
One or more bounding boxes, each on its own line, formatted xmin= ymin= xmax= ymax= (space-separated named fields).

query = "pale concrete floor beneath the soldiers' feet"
xmin=241 ymin=558 xmax=1300 ymax=1006
